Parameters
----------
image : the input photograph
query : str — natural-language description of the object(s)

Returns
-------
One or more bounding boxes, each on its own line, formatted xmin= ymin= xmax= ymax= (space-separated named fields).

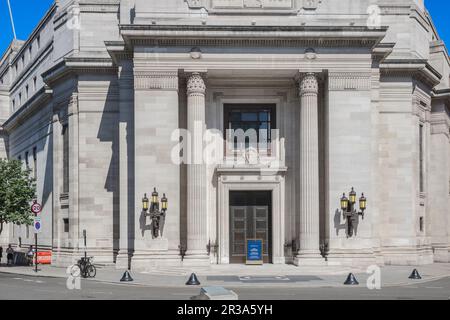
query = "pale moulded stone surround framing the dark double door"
xmin=217 ymin=166 xmax=287 ymax=264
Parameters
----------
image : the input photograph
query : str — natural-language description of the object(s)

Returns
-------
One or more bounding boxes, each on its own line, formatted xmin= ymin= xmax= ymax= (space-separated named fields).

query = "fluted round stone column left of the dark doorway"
xmin=186 ymin=73 xmax=209 ymax=264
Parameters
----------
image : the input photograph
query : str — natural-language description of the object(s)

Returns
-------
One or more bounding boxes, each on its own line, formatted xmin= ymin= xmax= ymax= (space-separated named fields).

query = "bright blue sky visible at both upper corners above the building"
xmin=0 ymin=0 xmax=450 ymax=55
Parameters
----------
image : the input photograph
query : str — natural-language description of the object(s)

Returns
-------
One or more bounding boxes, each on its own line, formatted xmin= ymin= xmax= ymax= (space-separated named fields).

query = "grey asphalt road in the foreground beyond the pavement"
xmin=0 ymin=273 xmax=450 ymax=300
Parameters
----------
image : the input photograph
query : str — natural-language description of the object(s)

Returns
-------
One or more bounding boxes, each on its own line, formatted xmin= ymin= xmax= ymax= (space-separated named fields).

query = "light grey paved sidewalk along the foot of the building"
xmin=0 ymin=263 xmax=450 ymax=288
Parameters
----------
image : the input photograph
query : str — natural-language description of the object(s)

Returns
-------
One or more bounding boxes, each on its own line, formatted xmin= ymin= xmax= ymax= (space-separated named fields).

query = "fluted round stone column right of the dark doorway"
xmin=295 ymin=73 xmax=324 ymax=265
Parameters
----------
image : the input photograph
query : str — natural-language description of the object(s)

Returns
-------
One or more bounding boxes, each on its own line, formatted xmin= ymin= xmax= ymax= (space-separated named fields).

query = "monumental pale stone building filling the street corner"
xmin=0 ymin=0 xmax=450 ymax=269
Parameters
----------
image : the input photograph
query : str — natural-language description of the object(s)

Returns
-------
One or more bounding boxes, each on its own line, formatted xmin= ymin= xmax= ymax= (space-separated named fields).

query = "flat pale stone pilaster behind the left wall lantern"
xmin=129 ymin=68 xmax=181 ymax=270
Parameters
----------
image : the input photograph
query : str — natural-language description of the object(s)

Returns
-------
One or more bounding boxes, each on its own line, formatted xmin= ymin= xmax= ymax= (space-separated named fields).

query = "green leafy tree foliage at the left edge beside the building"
xmin=0 ymin=159 xmax=36 ymax=234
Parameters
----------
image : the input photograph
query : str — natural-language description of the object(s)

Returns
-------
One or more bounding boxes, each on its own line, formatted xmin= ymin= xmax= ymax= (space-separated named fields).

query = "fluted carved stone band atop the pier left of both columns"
xmin=134 ymin=70 xmax=178 ymax=91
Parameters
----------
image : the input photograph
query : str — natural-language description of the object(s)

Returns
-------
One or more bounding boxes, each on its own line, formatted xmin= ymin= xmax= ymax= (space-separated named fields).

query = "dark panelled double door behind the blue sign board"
xmin=230 ymin=191 xmax=272 ymax=263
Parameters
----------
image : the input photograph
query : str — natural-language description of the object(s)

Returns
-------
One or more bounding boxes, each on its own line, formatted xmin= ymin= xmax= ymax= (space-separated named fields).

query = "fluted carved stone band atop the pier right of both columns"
xmin=328 ymin=71 xmax=372 ymax=91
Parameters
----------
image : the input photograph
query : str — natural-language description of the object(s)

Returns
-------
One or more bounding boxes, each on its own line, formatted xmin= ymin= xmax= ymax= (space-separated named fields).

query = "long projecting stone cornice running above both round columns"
xmin=120 ymin=24 xmax=387 ymax=49
